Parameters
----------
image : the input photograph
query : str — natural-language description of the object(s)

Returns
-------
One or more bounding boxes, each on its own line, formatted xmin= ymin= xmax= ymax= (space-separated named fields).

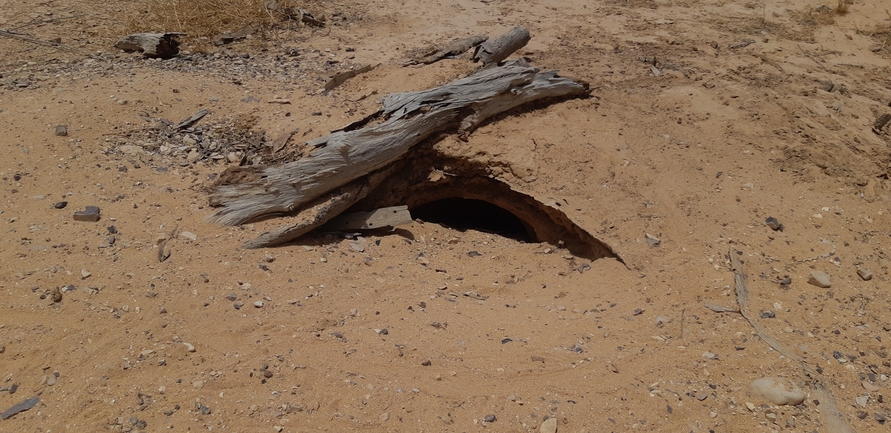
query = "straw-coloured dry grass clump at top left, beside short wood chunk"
xmin=126 ymin=0 xmax=314 ymax=39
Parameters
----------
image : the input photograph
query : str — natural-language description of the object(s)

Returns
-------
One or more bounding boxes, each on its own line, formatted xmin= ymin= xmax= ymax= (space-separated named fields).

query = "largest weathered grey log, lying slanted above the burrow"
xmin=209 ymin=63 xmax=588 ymax=230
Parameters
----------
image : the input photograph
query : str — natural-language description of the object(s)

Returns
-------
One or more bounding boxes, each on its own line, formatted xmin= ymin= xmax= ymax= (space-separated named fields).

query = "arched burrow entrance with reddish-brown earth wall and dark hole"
xmin=349 ymin=151 xmax=624 ymax=264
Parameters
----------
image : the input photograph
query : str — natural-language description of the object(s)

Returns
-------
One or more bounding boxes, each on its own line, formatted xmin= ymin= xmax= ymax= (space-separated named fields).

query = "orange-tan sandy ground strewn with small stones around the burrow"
xmin=0 ymin=0 xmax=891 ymax=432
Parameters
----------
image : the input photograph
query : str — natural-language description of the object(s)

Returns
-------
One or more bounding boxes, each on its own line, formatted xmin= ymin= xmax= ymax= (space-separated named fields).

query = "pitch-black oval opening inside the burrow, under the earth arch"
xmin=409 ymin=197 xmax=538 ymax=242
